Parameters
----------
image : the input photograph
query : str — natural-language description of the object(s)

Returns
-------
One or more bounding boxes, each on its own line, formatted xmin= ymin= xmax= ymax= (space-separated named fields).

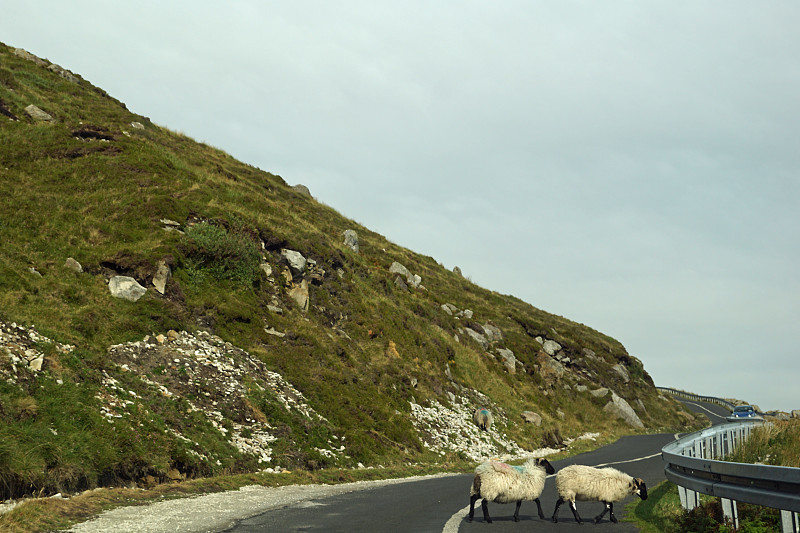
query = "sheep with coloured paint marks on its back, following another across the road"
xmin=467 ymin=458 xmax=555 ymax=524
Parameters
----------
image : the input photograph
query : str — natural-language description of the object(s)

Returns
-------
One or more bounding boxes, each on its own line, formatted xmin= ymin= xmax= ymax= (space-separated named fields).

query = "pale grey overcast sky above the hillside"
xmin=0 ymin=0 xmax=800 ymax=410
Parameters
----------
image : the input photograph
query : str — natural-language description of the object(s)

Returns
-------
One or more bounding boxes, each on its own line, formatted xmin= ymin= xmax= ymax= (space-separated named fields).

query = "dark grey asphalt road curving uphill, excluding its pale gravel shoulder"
xmin=226 ymin=401 xmax=728 ymax=533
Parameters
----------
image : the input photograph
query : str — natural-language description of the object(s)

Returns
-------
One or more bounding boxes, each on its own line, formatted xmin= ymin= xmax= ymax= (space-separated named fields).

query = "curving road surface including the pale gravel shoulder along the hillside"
xmin=71 ymin=401 xmax=728 ymax=533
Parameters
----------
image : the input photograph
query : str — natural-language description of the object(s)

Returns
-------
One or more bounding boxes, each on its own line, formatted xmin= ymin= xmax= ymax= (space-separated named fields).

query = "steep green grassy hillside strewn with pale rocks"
xmin=0 ymin=44 xmax=694 ymax=498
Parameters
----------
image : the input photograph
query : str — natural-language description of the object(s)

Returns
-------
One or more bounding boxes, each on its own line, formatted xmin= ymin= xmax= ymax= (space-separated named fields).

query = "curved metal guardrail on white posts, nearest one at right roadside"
xmin=661 ymin=422 xmax=800 ymax=533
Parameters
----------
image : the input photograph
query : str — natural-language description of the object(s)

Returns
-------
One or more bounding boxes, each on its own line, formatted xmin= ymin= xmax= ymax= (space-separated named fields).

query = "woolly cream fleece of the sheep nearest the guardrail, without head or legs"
xmin=556 ymin=465 xmax=633 ymax=502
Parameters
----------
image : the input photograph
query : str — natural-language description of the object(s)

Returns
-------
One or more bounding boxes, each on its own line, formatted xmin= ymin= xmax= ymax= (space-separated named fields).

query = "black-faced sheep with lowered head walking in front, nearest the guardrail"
xmin=553 ymin=465 xmax=647 ymax=524
